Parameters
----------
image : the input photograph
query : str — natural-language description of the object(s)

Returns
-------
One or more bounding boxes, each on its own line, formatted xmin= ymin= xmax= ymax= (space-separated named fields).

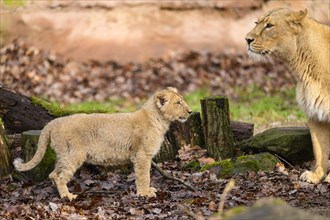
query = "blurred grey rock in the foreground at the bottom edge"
xmin=209 ymin=197 xmax=328 ymax=220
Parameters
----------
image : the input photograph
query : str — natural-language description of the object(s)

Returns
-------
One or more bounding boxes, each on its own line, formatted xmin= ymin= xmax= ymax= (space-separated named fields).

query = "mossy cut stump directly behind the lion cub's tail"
xmin=22 ymin=130 xmax=56 ymax=182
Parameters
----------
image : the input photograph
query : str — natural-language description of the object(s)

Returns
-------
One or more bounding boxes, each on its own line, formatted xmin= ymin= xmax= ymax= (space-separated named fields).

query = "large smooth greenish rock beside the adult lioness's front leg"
xmin=240 ymin=127 xmax=313 ymax=164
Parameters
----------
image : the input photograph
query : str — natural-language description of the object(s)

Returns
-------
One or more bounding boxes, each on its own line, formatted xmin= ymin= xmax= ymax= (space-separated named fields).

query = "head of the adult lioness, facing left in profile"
xmin=245 ymin=8 xmax=307 ymax=60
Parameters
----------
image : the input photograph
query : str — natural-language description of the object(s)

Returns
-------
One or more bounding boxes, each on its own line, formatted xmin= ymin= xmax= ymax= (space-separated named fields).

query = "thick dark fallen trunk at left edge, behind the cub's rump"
xmin=0 ymin=87 xmax=56 ymax=134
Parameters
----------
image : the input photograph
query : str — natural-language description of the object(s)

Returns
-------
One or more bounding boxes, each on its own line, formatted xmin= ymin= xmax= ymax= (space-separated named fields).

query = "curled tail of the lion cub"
xmin=13 ymin=125 xmax=51 ymax=171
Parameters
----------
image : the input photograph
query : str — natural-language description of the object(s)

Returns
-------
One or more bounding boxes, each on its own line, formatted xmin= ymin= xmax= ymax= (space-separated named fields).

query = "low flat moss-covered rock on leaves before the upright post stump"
xmin=202 ymin=153 xmax=279 ymax=178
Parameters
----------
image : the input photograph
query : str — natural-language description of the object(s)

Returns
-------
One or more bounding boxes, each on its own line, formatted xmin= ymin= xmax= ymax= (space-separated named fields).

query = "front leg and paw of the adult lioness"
xmin=300 ymin=120 xmax=330 ymax=183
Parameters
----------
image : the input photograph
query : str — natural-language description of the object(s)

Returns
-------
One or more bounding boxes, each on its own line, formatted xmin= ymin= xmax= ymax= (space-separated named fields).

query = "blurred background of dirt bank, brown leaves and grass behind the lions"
xmin=0 ymin=0 xmax=329 ymax=131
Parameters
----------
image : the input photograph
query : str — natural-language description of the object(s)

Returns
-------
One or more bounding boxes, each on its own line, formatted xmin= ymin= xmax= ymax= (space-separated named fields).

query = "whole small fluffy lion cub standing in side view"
xmin=14 ymin=87 xmax=191 ymax=200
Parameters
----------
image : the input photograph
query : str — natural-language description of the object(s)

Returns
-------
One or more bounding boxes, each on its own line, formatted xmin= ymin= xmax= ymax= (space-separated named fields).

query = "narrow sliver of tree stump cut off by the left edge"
xmin=0 ymin=124 xmax=10 ymax=179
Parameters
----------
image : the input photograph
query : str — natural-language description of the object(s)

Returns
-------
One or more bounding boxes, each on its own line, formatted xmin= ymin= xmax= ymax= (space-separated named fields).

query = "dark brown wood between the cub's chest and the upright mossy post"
xmin=154 ymin=112 xmax=204 ymax=162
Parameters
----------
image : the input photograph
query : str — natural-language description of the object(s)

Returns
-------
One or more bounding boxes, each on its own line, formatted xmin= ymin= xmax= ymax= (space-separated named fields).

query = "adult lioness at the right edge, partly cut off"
xmin=245 ymin=8 xmax=330 ymax=183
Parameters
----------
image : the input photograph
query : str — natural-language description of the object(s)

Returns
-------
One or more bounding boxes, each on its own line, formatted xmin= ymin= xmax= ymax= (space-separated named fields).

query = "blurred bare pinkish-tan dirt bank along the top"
xmin=1 ymin=0 xmax=329 ymax=62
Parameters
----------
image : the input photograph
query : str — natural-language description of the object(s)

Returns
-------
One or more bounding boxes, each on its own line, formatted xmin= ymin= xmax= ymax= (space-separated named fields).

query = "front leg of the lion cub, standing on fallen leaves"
xmin=132 ymin=152 xmax=157 ymax=197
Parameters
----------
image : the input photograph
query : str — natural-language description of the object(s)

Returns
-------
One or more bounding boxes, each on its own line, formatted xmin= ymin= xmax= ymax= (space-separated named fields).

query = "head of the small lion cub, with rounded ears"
xmin=154 ymin=87 xmax=191 ymax=122
